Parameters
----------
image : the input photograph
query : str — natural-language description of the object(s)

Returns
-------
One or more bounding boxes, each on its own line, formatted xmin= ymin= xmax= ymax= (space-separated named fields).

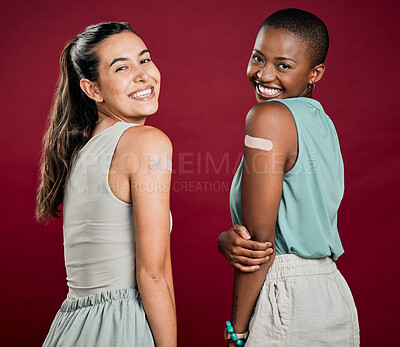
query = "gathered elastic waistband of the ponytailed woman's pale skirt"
xmin=60 ymin=288 xmax=140 ymax=312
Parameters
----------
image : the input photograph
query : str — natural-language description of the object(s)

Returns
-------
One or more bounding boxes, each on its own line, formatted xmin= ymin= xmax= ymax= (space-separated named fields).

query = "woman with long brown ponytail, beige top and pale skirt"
xmin=36 ymin=22 xmax=177 ymax=347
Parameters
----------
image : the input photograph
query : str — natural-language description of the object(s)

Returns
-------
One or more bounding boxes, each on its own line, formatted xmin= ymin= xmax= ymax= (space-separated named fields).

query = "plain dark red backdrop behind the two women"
xmin=0 ymin=0 xmax=400 ymax=346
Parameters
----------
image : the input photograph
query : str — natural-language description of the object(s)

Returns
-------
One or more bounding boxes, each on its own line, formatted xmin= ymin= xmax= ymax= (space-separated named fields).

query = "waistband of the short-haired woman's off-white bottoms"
xmin=266 ymin=254 xmax=337 ymax=280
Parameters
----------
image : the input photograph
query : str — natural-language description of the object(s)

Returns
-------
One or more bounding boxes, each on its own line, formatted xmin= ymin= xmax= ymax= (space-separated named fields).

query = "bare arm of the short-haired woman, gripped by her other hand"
xmin=230 ymin=102 xmax=297 ymax=345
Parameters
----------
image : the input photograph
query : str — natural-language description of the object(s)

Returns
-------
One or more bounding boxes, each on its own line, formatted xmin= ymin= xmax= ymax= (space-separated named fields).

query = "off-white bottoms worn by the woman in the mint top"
xmin=246 ymin=254 xmax=360 ymax=347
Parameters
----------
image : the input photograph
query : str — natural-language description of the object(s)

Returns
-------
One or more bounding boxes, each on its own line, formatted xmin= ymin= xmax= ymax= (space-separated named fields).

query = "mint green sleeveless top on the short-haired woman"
xmin=230 ymin=97 xmax=344 ymax=260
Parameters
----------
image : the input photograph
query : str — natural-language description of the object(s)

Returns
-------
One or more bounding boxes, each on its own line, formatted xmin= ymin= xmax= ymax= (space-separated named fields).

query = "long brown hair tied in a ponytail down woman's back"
xmin=35 ymin=22 xmax=136 ymax=221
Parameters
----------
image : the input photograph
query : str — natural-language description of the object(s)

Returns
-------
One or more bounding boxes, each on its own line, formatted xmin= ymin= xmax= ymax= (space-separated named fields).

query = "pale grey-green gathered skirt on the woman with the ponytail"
xmin=43 ymin=289 xmax=154 ymax=347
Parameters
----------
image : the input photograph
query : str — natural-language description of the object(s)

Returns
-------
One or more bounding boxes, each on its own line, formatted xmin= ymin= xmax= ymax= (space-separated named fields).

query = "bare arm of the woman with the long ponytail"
xmin=123 ymin=126 xmax=177 ymax=347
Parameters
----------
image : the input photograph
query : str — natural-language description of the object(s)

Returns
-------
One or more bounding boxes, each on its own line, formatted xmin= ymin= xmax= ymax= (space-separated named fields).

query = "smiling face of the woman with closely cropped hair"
xmin=247 ymin=27 xmax=325 ymax=103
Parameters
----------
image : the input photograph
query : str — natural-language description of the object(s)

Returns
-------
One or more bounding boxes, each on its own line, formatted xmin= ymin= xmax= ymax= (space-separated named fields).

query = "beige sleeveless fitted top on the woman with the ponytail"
xmin=63 ymin=122 xmax=172 ymax=300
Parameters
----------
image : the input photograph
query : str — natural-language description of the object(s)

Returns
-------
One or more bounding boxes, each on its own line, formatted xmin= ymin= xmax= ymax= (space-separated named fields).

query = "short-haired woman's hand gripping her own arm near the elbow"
xmin=218 ymin=224 xmax=273 ymax=272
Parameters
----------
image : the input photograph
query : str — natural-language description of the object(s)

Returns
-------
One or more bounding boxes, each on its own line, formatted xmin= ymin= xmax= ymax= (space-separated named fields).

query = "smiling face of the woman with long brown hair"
xmin=94 ymin=31 xmax=161 ymax=122
